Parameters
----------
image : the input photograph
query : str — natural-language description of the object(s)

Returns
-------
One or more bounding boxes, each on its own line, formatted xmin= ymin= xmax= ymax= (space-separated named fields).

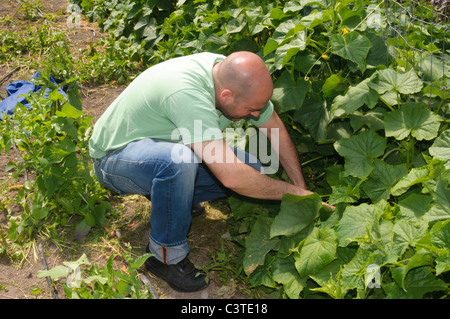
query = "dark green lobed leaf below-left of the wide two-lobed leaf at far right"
xmin=334 ymin=130 xmax=386 ymax=178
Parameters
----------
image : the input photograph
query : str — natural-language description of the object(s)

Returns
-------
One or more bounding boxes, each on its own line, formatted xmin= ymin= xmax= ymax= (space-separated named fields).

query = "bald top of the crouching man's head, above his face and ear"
xmin=215 ymin=51 xmax=273 ymax=99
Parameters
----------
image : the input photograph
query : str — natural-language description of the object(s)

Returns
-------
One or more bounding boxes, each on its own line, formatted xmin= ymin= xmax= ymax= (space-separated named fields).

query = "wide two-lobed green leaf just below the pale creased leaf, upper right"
xmin=384 ymin=102 xmax=442 ymax=140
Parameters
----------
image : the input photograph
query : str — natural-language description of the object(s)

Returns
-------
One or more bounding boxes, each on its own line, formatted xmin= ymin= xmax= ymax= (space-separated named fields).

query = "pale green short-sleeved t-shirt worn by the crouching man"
xmin=89 ymin=53 xmax=273 ymax=158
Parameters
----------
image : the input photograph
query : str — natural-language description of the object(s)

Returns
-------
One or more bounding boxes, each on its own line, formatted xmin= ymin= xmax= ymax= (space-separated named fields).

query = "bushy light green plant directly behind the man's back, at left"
xmin=0 ymin=77 xmax=111 ymax=241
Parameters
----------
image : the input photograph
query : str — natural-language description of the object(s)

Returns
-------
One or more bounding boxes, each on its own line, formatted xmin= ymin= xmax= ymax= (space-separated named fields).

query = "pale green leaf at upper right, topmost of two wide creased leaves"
xmin=369 ymin=69 xmax=422 ymax=94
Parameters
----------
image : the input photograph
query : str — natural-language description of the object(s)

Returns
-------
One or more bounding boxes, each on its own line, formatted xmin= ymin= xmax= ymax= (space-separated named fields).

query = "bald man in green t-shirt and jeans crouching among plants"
xmin=90 ymin=52 xmax=312 ymax=292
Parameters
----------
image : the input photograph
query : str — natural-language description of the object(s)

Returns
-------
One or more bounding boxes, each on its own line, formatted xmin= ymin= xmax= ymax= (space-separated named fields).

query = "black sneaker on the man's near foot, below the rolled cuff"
xmin=145 ymin=256 xmax=208 ymax=292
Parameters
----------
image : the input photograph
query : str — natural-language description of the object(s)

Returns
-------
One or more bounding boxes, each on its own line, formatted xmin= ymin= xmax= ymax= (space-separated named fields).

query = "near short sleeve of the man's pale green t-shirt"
xmin=163 ymin=90 xmax=223 ymax=145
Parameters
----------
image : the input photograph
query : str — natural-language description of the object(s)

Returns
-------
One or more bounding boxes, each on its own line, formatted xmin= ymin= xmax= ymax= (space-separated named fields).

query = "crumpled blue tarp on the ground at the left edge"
xmin=0 ymin=71 xmax=66 ymax=121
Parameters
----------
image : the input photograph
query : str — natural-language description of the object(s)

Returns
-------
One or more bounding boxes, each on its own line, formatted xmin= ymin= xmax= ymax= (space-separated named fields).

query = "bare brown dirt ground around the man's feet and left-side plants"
xmin=0 ymin=0 xmax=253 ymax=299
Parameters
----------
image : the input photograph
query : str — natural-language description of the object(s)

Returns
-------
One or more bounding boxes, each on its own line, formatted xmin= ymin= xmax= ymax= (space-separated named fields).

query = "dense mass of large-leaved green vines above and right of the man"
xmin=67 ymin=0 xmax=450 ymax=298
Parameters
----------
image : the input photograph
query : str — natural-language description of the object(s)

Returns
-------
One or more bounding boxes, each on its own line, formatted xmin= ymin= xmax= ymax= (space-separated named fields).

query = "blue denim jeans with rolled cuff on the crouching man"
xmin=94 ymin=138 xmax=261 ymax=264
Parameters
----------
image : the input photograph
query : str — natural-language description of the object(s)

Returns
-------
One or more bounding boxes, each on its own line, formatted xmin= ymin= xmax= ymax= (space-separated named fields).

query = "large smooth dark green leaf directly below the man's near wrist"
xmin=270 ymin=193 xmax=322 ymax=237
